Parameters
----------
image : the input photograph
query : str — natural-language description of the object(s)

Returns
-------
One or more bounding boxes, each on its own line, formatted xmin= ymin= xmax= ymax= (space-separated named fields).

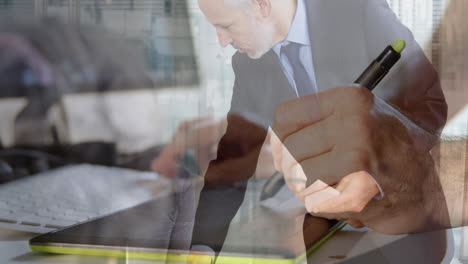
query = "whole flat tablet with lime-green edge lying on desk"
xmin=30 ymin=182 xmax=343 ymax=264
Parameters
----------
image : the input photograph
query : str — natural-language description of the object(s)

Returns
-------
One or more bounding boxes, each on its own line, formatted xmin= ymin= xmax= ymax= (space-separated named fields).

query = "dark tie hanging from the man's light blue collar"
xmin=281 ymin=42 xmax=313 ymax=96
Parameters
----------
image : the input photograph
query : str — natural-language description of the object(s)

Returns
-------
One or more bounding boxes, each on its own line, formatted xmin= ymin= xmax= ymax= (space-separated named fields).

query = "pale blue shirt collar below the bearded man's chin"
xmin=273 ymin=0 xmax=310 ymax=55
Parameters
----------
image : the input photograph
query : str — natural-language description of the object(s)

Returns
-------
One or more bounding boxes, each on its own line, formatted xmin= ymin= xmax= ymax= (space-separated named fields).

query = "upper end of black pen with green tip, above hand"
xmin=354 ymin=40 xmax=406 ymax=91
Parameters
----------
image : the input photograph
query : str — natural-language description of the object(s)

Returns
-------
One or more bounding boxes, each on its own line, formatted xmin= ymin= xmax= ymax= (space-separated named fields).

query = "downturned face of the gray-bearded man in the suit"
xmin=199 ymin=0 xmax=275 ymax=59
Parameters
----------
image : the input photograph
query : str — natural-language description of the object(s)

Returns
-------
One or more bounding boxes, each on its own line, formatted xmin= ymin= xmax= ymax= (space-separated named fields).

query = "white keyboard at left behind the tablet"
xmin=0 ymin=165 xmax=171 ymax=233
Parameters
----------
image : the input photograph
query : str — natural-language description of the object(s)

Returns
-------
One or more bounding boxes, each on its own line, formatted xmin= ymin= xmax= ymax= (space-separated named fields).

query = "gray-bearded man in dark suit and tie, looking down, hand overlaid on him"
xmin=190 ymin=0 xmax=449 ymax=256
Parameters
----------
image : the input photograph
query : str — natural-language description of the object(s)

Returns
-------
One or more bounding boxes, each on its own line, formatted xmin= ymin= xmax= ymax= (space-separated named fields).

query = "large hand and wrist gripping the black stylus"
xmin=271 ymin=86 xmax=448 ymax=234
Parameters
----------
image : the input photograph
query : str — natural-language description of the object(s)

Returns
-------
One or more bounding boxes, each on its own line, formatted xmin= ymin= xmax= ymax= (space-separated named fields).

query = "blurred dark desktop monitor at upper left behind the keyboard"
xmin=0 ymin=0 xmax=199 ymax=94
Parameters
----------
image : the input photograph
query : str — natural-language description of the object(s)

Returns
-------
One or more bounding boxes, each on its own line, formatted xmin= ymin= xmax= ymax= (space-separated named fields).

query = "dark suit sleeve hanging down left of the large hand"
xmin=192 ymin=112 xmax=266 ymax=251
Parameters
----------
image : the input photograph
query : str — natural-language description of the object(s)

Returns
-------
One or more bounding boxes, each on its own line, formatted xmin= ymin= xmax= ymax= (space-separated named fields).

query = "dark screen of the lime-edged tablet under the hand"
xmin=30 ymin=179 xmax=334 ymax=258
